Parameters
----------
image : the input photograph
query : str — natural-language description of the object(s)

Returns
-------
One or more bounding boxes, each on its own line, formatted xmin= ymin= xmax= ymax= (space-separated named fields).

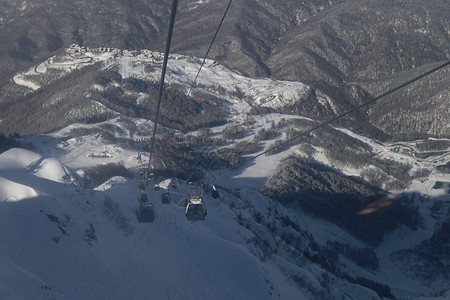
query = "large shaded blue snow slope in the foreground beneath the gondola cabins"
xmin=0 ymin=145 xmax=388 ymax=299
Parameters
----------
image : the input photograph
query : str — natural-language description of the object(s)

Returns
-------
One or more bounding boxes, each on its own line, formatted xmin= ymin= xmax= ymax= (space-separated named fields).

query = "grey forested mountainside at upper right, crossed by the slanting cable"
xmin=267 ymin=1 xmax=450 ymax=139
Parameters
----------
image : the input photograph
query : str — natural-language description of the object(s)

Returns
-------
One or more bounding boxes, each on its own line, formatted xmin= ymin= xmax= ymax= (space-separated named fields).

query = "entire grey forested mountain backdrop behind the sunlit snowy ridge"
xmin=0 ymin=0 xmax=450 ymax=138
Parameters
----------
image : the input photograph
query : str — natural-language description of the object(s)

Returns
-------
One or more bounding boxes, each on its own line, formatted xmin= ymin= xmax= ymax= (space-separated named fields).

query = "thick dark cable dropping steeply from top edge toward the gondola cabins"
xmin=148 ymin=0 xmax=178 ymax=172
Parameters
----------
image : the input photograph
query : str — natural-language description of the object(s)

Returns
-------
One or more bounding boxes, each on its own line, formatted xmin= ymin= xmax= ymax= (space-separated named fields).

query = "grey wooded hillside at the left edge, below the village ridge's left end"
xmin=0 ymin=64 xmax=110 ymax=135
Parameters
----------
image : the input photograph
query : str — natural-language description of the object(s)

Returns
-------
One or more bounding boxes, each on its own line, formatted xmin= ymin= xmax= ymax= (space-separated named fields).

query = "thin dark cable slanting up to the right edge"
xmin=213 ymin=61 xmax=450 ymax=174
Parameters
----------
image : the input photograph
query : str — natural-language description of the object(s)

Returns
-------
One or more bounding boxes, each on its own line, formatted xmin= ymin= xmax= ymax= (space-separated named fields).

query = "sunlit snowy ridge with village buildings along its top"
xmin=12 ymin=45 xmax=310 ymax=112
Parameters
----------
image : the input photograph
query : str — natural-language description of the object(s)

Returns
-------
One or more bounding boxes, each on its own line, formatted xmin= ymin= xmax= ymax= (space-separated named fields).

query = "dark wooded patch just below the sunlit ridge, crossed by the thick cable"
xmin=94 ymin=70 xmax=226 ymax=132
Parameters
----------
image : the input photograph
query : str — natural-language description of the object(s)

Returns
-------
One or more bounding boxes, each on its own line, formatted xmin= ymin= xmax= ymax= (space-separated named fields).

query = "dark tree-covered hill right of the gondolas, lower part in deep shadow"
xmin=263 ymin=157 xmax=420 ymax=245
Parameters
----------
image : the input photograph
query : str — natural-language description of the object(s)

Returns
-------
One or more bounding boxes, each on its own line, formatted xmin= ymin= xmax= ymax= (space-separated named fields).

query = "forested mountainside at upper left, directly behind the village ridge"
xmin=0 ymin=0 xmax=342 ymax=84
